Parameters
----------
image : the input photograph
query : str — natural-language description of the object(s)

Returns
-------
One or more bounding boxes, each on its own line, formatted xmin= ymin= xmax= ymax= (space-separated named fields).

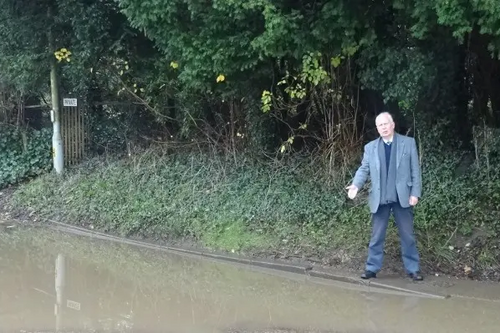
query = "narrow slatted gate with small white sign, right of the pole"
xmin=60 ymin=98 xmax=88 ymax=166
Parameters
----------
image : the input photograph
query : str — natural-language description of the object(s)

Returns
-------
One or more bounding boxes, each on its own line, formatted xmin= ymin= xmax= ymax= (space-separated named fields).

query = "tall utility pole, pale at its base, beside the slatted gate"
xmin=48 ymin=7 xmax=64 ymax=174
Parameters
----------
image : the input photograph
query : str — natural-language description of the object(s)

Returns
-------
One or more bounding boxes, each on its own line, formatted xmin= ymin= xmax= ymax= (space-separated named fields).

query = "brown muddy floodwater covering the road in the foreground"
xmin=0 ymin=228 xmax=500 ymax=333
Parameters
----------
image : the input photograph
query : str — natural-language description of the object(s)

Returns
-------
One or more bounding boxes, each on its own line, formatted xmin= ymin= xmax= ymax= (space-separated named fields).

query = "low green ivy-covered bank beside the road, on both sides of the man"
xmin=7 ymin=149 xmax=500 ymax=278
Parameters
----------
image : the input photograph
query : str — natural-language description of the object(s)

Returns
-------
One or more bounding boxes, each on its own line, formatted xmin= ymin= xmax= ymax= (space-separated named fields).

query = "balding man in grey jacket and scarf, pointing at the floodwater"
xmin=347 ymin=112 xmax=423 ymax=281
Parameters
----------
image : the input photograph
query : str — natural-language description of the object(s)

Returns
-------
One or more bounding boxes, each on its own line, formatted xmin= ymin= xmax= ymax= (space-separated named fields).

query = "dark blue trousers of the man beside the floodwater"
xmin=366 ymin=203 xmax=420 ymax=273
